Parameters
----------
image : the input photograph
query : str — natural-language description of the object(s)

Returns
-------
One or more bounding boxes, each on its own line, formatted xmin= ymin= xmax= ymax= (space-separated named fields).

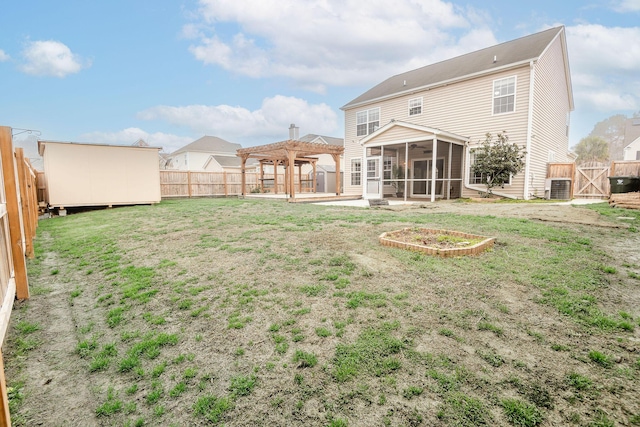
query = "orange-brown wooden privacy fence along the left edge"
xmin=0 ymin=126 xmax=38 ymax=426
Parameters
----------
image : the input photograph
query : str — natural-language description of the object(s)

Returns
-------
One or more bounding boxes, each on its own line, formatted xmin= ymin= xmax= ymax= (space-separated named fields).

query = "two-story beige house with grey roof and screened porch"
xmin=342 ymin=27 xmax=573 ymax=201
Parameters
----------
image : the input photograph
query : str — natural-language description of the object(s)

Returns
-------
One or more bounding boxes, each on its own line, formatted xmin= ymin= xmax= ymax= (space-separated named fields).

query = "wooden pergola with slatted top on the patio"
xmin=236 ymin=139 xmax=344 ymax=200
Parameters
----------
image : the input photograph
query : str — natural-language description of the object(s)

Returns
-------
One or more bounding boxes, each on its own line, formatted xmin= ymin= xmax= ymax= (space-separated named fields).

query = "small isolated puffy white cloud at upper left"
xmin=22 ymin=40 xmax=91 ymax=78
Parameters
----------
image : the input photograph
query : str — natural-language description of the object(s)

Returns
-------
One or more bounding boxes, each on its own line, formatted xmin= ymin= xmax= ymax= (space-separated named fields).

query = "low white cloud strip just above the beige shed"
xmin=80 ymin=128 xmax=194 ymax=153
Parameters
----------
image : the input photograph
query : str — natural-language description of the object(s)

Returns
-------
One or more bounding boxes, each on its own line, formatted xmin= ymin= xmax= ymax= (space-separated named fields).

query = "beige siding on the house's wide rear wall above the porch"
xmin=345 ymin=65 xmax=530 ymax=198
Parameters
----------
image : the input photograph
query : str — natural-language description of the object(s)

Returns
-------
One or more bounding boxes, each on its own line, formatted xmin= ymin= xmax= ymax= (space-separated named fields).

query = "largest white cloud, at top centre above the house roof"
xmin=183 ymin=0 xmax=496 ymax=92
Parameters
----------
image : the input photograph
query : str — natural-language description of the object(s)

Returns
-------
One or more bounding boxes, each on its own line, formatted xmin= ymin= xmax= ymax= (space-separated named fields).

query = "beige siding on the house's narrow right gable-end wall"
xmin=529 ymin=37 xmax=572 ymax=197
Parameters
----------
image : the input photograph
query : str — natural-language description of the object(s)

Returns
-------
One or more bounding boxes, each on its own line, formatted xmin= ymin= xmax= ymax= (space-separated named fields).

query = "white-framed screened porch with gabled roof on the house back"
xmin=358 ymin=121 xmax=469 ymax=202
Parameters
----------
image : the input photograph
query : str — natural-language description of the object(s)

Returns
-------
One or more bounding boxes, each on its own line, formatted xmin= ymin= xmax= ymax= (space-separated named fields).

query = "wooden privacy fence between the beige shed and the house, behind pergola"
xmin=160 ymin=170 xmax=312 ymax=198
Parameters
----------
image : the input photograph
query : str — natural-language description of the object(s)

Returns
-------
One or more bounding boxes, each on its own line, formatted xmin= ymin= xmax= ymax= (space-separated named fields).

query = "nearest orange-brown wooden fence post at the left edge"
xmin=0 ymin=126 xmax=29 ymax=299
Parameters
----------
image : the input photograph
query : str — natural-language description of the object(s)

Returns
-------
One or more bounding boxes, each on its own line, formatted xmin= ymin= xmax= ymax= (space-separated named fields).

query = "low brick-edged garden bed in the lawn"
xmin=379 ymin=227 xmax=496 ymax=257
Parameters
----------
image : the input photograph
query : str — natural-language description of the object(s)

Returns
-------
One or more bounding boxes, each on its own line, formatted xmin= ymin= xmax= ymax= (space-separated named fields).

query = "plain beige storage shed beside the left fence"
xmin=38 ymin=141 xmax=160 ymax=209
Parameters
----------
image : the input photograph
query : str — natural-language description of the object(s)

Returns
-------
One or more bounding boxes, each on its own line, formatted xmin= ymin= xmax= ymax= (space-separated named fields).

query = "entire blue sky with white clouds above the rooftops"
xmin=0 ymin=0 xmax=640 ymax=160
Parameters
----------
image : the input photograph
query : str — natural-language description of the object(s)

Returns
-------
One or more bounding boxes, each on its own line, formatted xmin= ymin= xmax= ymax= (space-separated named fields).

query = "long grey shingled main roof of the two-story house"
xmin=341 ymin=26 xmax=570 ymax=110
